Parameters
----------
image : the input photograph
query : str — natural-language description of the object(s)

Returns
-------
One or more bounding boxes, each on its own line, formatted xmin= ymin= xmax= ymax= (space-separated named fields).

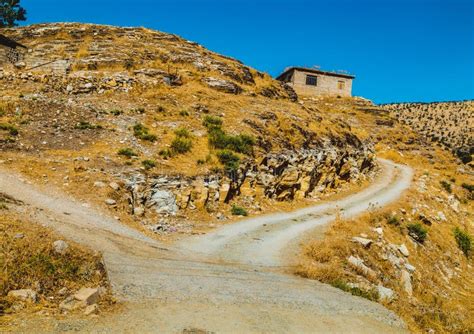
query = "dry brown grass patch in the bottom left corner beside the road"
xmin=0 ymin=205 xmax=110 ymax=314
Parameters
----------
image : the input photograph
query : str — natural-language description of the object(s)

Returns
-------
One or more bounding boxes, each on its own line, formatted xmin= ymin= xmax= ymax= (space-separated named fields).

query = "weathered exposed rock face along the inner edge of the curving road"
xmin=127 ymin=142 xmax=376 ymax=215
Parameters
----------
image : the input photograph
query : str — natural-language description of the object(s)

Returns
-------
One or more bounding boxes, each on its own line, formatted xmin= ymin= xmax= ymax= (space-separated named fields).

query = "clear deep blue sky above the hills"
xmin=21 ymin=0 xmax=474 ymax=103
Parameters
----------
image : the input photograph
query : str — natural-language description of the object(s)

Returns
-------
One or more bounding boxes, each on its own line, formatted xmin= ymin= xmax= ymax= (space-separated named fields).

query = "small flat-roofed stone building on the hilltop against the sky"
xmin=277 ymin=67 xmax=355 ymax=97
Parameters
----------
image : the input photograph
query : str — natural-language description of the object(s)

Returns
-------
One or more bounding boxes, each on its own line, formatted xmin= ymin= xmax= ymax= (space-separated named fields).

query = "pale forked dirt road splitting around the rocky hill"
xmin=0 ymin=160 xmax=412 ymax=333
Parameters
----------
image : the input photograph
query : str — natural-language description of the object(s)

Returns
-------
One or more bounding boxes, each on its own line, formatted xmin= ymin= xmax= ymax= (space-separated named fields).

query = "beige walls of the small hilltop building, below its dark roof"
xmin=288 ymin=70 xmax=352 ymax=96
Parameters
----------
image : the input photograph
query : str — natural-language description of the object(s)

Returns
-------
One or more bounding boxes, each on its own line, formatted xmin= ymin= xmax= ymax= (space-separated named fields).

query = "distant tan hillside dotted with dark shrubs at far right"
xmin=381 ymin=100 xmax=474 ymax=163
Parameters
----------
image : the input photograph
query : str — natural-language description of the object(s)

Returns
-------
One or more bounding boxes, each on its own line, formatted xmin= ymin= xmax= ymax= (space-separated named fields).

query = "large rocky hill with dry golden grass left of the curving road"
xmin=0 ymin=24 xmax=376 ymax=234
